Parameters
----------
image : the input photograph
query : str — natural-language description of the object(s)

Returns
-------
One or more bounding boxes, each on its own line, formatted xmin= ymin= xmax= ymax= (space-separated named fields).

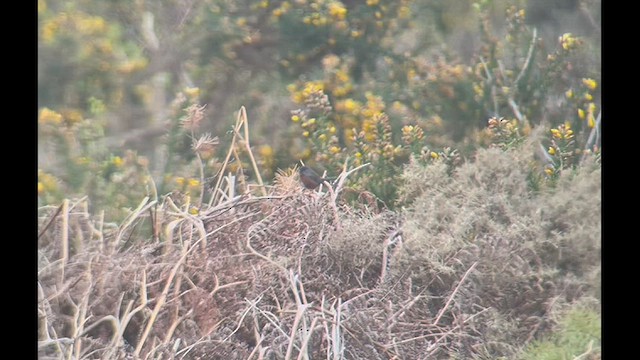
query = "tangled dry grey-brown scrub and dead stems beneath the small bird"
xmin=38 ymin=117 xmax=600 ymax=359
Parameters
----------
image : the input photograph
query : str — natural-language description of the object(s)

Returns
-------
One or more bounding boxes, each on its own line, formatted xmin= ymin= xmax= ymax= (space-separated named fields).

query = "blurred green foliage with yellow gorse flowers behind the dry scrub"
xmin=38 ymin=0 xmax=601 ymax=212
